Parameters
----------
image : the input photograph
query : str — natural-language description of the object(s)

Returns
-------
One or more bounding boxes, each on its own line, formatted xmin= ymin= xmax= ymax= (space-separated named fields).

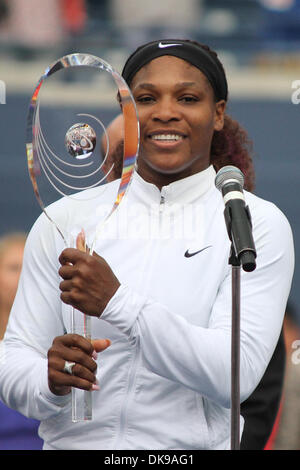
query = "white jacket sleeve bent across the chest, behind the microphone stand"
xmin=101 ymin=204 xmax=294 ymax=408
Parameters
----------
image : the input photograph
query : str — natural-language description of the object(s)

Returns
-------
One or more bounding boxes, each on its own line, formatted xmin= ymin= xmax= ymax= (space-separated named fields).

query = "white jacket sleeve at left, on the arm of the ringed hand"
xmin=0 ymin=215 xmax=70 ymax=420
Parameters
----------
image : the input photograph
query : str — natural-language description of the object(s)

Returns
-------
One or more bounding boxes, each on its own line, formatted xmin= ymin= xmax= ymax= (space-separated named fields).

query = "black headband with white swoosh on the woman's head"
xmin=122 ymin=39 xmax=228 ymax=101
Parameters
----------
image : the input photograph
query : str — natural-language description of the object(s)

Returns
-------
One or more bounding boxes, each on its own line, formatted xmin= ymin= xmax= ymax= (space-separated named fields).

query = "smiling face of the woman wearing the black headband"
xmin=131 ymin=56 xmax=225 ymax=184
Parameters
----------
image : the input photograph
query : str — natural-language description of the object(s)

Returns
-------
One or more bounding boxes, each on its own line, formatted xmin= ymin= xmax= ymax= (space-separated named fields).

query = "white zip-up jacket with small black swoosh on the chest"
xmin=0 ymin=167 xmax=294 ymax=449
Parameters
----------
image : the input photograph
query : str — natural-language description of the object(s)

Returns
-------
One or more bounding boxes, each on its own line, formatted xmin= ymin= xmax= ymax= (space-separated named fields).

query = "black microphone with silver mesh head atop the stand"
xmin=215 ymin=165 xmax=256 ymax=272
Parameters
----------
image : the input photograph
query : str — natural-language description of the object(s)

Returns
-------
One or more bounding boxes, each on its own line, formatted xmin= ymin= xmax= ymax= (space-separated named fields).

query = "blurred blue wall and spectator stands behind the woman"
xmin=0 ymin=0 xmax=300 ymax=316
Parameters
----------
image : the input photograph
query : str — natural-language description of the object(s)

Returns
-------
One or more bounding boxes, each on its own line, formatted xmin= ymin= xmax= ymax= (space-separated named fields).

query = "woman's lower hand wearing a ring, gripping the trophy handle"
xmin=48 ymin=334 xmax=111 ymax=395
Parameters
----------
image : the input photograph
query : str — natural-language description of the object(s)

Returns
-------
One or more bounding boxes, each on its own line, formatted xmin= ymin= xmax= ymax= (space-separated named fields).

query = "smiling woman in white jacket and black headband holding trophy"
xmin=0 ymin=40 xmax=293 ymax=449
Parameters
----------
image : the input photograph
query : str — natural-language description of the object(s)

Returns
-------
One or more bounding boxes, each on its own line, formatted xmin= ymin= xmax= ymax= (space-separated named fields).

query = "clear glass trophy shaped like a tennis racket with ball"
xmin=26 ymin=53 xmax=139 ymax=422
